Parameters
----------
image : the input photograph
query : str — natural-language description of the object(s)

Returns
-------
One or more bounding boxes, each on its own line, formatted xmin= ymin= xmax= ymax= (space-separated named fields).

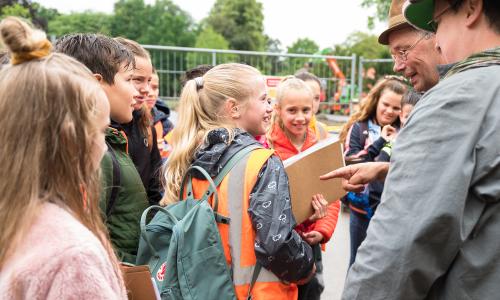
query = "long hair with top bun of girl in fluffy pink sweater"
xmin=0 ymin=17 xmax=121 ymax=276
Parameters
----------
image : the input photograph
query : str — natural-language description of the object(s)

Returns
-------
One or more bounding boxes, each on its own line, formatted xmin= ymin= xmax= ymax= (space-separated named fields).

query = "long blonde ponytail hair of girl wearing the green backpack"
xmin=160 ymin=63 xmax=261 ymax=205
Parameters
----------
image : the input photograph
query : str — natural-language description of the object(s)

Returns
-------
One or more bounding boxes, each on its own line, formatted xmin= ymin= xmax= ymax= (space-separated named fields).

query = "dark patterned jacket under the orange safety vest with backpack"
xmin=192 ymin=129 xmax=313 ymax=282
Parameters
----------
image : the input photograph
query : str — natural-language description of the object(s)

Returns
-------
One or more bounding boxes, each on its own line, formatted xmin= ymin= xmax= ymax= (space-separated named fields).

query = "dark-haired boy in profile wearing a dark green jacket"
xmin=55 ymin=34 xmax=148 ymax=263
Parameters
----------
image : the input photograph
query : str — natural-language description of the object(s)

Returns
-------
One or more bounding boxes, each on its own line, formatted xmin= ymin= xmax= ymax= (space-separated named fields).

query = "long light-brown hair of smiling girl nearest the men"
xmin=339 ymin=76 xmax=406 ymax=143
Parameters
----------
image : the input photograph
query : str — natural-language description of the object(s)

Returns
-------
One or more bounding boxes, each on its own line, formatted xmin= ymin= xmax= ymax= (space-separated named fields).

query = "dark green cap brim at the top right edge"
xmin=403 ymin=0 xmax=434 ymax=32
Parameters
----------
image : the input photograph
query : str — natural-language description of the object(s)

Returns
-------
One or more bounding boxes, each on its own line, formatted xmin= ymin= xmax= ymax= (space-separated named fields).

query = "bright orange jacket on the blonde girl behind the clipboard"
xmin=271 ymin=124 xmax=340 ymax=243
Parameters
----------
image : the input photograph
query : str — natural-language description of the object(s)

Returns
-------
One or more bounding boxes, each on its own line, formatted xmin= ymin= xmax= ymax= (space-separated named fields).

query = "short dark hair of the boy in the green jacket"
xmin=55 ymin=33 xmax=135 ymax=85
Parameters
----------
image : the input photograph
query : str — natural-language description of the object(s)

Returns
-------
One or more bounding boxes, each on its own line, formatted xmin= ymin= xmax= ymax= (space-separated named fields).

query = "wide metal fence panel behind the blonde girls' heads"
xmin=144 ymin=45 xmax=356 ymax=115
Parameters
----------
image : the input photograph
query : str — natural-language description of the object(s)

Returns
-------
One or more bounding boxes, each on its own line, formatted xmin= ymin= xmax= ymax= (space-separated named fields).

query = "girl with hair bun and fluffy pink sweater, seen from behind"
xmin=0 ymin=17 xmax=127 ymax=299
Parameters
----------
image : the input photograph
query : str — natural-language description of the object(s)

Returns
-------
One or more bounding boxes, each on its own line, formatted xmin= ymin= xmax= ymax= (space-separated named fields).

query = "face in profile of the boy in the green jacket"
xmin=101 ymin=65 xmax=139 ymax=124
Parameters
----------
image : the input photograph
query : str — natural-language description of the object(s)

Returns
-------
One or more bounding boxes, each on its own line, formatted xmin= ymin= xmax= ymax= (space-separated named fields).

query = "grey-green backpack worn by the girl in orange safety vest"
xmin=136 ymin=147 xmax=260 ymax=300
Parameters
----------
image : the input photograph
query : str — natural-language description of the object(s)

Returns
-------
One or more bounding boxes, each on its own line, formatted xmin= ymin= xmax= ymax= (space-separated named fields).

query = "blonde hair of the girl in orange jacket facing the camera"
xmin=266 ymin=76 xmax=313 ymax=147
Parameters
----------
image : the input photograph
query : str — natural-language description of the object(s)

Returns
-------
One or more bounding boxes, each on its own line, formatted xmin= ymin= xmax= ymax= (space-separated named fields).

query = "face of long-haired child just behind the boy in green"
xmin=132 ymin=56 xmax=153 ymax=110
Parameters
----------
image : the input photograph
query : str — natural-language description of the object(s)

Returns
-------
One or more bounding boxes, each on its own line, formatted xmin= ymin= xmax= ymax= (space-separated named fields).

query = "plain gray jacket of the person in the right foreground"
xmin=342 ymin=66 xmax=500 ymax=300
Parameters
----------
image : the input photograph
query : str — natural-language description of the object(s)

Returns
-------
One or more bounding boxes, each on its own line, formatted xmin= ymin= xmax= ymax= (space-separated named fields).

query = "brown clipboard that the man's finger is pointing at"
xmin=283 ymin=137 xmax=345 ymax=224
